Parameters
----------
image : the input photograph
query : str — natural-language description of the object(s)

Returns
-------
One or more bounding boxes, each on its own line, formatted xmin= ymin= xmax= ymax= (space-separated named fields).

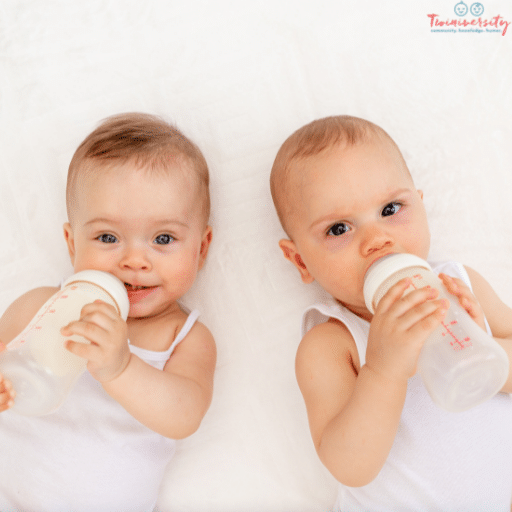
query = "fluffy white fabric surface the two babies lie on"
xmin=0 ymin=0 xmax=512 ymax=512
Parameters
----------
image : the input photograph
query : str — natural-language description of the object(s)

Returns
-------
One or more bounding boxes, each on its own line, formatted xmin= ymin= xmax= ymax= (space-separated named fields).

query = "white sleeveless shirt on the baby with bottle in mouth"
xmin=303 ymin=262 xmax=512 ymax=512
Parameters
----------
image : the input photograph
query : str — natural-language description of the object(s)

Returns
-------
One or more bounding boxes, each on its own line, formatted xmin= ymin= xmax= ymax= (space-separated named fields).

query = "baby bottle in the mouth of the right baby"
xmin=364 ymin=254 xmax=509 ymax=412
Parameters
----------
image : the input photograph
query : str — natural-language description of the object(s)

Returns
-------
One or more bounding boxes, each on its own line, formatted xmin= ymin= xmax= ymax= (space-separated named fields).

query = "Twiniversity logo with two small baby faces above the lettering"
xmin=427 ymin=0 xmax=511 ymax=36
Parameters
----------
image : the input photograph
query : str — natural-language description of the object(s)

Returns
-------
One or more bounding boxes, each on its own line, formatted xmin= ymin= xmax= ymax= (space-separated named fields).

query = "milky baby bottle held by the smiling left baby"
xmin=0 ymin=270 xmax=130 ymax=416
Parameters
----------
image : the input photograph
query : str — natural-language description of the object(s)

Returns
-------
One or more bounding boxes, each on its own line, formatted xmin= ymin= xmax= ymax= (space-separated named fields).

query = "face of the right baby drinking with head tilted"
xmin=281 ymin=140 xmax=430 ymax=317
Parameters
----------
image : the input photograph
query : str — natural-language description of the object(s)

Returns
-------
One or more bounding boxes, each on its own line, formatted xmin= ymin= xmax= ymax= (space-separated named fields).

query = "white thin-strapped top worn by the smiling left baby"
xmin=0 ymin=310 xmax=199 ymax=512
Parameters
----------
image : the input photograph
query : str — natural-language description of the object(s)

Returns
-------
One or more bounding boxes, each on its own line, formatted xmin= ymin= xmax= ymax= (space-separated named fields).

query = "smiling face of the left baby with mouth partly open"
xmin=64 ymin=164 xmax=211 ymax=317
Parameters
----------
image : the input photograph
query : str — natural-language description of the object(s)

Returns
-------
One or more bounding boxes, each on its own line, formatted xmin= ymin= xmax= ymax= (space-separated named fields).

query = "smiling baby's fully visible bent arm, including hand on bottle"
xmin=61 ymin=303 xmax=216 ymax=439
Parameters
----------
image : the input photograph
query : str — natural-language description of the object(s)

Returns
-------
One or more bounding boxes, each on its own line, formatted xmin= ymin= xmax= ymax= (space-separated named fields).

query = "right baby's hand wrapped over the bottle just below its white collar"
xmin=366 ymin=279 xmax=449 ymax=381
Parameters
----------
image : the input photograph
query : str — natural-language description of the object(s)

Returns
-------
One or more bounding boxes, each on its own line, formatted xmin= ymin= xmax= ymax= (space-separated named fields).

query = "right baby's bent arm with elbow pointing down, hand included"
xmin=296 ymin=280 xmax=447 ymax=487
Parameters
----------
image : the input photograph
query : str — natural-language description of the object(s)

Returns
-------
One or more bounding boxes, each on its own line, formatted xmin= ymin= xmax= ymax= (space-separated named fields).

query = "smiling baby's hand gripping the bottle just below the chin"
xmin=61 ymin=300 xmax=130 ymax=382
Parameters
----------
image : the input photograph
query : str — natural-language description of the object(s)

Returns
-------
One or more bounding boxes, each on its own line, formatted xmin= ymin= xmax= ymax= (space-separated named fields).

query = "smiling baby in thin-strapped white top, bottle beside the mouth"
xmin=0 ymin=114 xmax=216 ymax=512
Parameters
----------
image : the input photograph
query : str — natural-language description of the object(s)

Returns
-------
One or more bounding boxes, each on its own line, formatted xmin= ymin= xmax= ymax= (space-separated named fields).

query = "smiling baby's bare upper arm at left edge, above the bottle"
xmin=0 ymin=286 xmax=59 ymax=343
